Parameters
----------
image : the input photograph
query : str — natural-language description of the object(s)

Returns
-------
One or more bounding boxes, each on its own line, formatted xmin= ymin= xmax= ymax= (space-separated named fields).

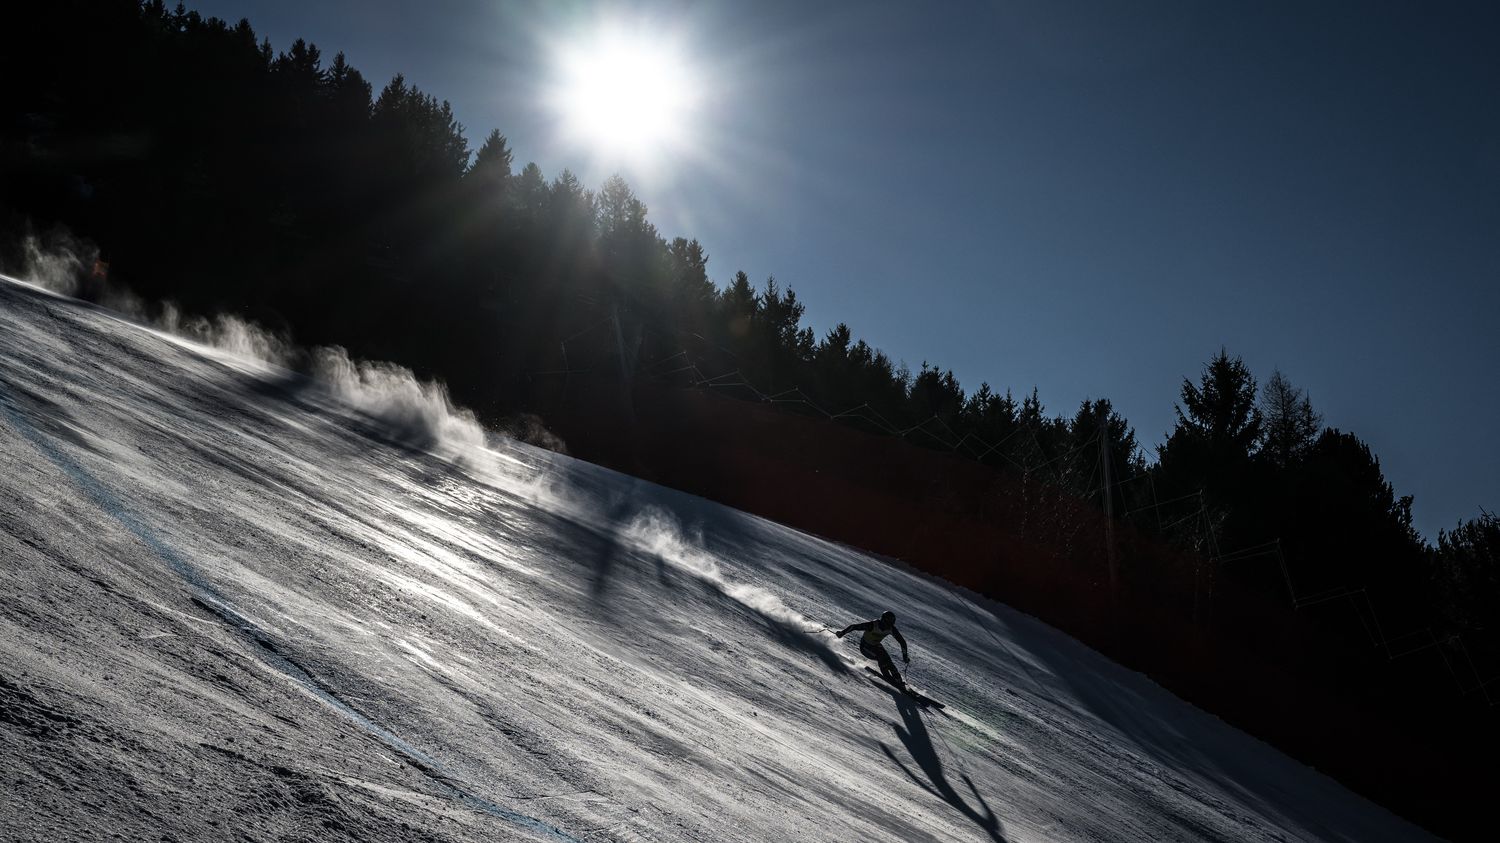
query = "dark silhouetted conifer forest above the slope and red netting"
xmin=0 ymin=0 xmax=1500 ymax=666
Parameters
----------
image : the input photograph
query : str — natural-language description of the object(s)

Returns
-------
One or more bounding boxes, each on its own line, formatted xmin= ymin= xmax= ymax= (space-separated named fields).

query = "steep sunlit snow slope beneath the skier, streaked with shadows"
xmin=0 ymin=274 xmax=1430 ymax=842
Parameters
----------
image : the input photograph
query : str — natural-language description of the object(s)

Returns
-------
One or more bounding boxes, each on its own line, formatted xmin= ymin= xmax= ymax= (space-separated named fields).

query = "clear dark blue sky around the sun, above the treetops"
xmin=189 ymin=0 xmax=1500 ymax=537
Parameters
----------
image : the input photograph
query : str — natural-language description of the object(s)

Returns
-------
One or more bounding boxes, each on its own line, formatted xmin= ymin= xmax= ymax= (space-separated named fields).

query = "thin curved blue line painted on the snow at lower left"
xmin=0 ymin=381 xmax=582 ymax=843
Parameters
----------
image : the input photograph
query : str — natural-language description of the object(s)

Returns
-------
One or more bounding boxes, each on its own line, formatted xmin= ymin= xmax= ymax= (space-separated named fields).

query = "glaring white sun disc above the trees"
xmin=551 ymin=30 xmax=698 ymax=159
